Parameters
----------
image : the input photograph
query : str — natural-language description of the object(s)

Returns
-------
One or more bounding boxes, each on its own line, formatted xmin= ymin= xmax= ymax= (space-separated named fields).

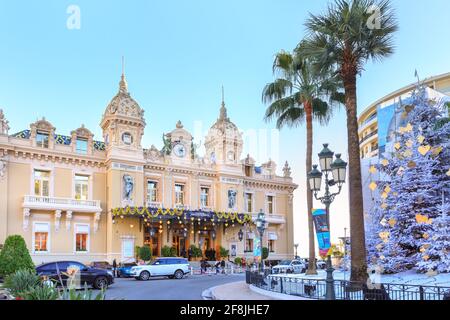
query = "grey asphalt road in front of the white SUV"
xmin=101 ymin=274 xmax=245 ymax=300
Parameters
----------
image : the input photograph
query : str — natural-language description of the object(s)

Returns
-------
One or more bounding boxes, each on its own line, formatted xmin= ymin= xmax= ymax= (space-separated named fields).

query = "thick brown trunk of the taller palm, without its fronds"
xmin=343 ymin=72 xmax=368 ymax=282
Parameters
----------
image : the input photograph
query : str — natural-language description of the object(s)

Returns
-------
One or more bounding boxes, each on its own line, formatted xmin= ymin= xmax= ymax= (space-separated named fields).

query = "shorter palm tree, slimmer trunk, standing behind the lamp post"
xmin=262 ymin=49 xmax=343 ymax=274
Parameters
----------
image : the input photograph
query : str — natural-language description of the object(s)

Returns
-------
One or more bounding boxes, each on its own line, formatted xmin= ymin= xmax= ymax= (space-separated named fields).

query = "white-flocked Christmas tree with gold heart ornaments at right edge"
xmin=366 ymin=87 xmax=450 ymax=273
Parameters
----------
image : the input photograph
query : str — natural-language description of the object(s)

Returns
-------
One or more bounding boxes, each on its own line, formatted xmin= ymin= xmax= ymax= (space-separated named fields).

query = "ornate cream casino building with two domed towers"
xmin=0 ymin=74 xmax=297 ymax=264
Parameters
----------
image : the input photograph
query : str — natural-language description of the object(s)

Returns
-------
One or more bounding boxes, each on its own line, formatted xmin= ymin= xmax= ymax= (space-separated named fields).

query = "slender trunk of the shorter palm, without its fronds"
xmin=303 ymin=101 xmax=317 ymax=275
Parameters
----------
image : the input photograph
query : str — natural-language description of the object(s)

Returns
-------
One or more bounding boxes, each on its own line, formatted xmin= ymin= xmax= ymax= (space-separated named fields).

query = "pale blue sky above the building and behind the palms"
xmin=0 ymin=0 xmax=450 ymax=254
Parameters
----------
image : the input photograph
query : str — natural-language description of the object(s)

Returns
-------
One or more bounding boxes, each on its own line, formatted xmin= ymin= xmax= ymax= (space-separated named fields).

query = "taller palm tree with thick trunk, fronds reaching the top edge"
xmin=302 ymin=0 xmax=398 ymax=281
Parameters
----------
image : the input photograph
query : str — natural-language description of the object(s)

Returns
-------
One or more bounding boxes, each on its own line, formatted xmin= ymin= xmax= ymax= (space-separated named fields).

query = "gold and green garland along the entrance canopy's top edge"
xmin=111 ymin=207 xmax=252 ymax=224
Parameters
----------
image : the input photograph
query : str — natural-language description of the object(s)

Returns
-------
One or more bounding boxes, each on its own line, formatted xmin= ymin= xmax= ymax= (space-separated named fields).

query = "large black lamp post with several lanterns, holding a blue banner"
xmin=308 ymin=143 xmax=347 ymax=300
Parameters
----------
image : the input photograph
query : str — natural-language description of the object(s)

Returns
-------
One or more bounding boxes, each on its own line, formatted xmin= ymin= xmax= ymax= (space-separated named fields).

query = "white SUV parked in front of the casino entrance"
xmin=130 ymin=258 xmax=189 ymax=281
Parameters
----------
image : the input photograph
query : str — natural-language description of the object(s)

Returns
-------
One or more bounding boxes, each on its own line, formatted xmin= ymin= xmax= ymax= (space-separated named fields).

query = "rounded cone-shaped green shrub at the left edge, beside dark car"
xmin=0 ymin=235 xmax=35 ymax=277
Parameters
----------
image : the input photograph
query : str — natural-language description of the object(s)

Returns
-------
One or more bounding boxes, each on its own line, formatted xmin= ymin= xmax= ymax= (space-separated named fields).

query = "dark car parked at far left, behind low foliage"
xmin=36 ymin=261 xmax=114 ymax=289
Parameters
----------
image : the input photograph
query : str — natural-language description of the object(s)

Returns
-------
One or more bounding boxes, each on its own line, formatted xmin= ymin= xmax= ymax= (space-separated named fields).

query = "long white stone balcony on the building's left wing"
xmin=22 ymin=196 xmax=102 ymax=213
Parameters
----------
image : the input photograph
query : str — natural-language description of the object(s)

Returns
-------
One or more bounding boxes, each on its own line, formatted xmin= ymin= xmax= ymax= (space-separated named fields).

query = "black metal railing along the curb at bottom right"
xmin=246 ymin=271 xmax=450 ymax=300
